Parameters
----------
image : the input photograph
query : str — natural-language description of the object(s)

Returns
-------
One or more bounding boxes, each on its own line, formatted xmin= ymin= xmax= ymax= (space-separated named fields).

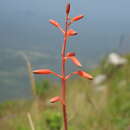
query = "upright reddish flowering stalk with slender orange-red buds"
xmin=33 ymin=3 xmax=93 ymax=130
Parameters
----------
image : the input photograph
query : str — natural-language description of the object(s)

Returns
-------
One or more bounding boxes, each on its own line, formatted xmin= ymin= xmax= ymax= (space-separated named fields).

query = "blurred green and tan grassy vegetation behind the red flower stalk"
xmin=0 ymin=55 xmax=130 ymax=130
